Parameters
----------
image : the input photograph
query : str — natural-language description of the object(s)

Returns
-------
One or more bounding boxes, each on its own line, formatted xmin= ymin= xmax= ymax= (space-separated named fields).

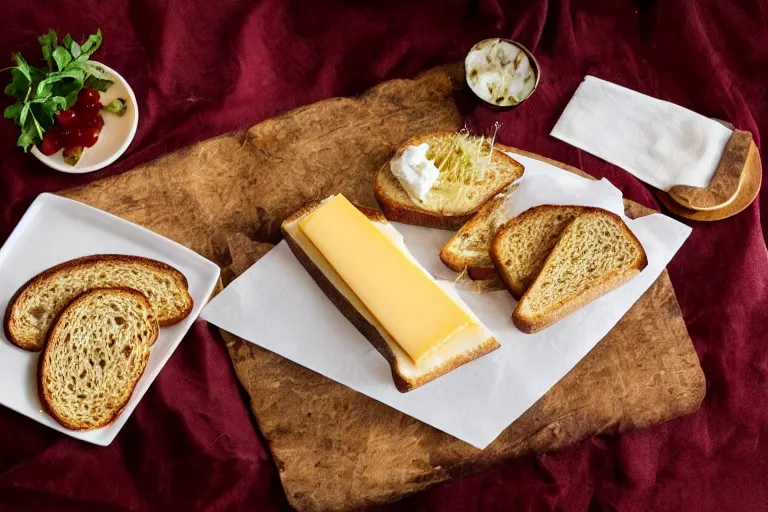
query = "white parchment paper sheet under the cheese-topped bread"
xmin=201 ymin=154 xmax=690 ymax=448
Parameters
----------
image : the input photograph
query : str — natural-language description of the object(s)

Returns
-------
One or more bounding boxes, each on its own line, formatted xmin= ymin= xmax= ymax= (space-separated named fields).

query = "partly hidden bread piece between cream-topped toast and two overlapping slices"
xmin=440 ymin=192 xmax=507 ymax=280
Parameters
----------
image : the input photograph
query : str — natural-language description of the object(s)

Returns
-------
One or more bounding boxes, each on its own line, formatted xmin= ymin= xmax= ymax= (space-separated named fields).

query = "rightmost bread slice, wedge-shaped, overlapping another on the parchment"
xmin=512 ymin=208 xmax=648 ymax=333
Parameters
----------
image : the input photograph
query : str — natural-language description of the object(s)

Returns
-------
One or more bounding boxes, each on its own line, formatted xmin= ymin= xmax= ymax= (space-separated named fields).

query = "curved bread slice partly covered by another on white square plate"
xmin=4 ymin=254 xmax=192 ymax=351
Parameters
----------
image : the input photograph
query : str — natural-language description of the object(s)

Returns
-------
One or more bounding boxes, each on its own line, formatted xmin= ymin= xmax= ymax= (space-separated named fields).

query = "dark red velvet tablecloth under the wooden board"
xmin=0 ymin=0 xmax=768 ymax=511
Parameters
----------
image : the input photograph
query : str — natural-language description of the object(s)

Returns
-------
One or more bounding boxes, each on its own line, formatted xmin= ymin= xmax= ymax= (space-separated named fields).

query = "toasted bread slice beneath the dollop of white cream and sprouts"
xmin=373 ymin=132 xmax=523 ymax=230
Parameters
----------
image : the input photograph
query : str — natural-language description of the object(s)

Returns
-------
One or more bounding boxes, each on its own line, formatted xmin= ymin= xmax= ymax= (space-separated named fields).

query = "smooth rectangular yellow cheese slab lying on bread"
xmin=299 ymin=195 xmax=473 ymax=363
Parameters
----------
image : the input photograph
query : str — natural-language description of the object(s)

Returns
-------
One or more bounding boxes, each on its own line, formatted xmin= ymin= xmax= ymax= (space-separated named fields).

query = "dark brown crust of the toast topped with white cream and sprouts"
xmin=373 ymin=132 xmax=525 ymax=231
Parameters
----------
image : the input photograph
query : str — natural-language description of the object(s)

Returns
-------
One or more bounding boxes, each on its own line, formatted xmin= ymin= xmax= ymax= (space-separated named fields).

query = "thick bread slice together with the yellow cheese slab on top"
xmin=281 ymin=196 xmax=499 ymax=392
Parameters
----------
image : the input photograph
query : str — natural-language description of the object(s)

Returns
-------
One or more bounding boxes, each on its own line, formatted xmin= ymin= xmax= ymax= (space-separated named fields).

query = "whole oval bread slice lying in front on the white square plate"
xmin=38 ymin=288 xmax=159 ymax=430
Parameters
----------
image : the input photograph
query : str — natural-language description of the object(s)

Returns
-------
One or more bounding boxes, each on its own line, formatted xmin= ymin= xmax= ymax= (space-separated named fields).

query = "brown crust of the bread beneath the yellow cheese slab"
xmin=281 ymin=201 xmax=501 ymax=393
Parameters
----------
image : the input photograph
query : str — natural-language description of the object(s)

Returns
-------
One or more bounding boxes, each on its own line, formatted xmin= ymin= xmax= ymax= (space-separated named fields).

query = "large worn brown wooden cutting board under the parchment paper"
xmin=62 ymin=65 xmax=704 ymax=510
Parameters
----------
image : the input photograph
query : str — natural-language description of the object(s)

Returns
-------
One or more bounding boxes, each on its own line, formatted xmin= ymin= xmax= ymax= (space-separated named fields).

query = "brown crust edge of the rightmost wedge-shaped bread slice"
xmin=512 ymin=207 xmax=648 ymax=334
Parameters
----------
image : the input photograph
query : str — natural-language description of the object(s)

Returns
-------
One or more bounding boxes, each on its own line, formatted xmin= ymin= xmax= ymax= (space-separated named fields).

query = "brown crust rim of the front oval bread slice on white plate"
xmin=37 ymin=287 xmax=160 ymax=430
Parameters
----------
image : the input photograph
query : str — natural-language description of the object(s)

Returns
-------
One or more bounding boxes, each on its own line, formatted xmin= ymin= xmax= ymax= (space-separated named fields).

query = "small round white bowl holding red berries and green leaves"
xmin=32 ymin=62 xmax=139 ymax=174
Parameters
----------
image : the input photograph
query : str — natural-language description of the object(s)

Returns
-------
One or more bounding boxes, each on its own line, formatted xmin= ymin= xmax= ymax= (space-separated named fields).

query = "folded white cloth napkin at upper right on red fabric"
xmin=551 ymin=76 xmax=733 ymax=190
